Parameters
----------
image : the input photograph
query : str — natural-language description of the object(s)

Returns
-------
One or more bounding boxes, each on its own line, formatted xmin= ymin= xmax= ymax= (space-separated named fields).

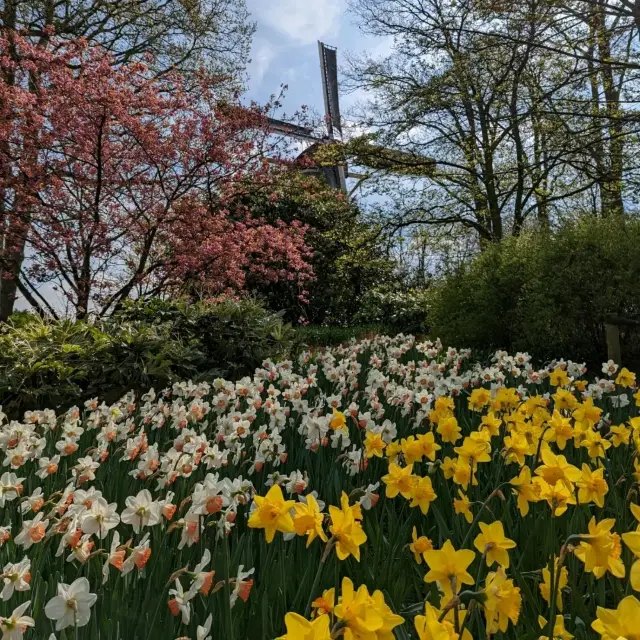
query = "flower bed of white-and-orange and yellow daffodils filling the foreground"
xmin=0 ymin=335 xmax=640 ymax=640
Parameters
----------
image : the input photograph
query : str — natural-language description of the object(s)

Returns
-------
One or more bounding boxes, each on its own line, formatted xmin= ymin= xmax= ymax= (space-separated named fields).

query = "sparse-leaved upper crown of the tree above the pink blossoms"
xmin=0 ymin=0 xmax=255 ymax=79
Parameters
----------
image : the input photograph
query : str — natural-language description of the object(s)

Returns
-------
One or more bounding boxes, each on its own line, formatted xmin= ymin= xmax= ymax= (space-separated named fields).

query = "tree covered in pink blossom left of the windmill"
xmin=0 ymin=33 xmax=311 ymax=318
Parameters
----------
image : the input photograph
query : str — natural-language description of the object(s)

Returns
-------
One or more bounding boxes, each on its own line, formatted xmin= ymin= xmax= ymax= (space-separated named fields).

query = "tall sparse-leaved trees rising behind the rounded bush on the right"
xmin=346 ymin=0 xmax=637 ymax=246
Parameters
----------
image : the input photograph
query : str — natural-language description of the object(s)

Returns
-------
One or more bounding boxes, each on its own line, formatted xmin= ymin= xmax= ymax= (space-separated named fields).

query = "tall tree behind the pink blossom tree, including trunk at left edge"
xmin=0 ymin=0 xmax=254 ymax=320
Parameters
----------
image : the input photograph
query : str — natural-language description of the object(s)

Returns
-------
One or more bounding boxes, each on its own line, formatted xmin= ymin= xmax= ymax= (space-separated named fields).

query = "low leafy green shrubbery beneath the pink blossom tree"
xmin=0 ymin=300 xmax=295 ymax=416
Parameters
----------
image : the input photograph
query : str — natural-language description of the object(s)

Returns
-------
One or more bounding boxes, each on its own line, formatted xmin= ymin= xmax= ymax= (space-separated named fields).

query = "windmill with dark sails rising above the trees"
xmin=268 ymin=41 xmax=435 ymax=192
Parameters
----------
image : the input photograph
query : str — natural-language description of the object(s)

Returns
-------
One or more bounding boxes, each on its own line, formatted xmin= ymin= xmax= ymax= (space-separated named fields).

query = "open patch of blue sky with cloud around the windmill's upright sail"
xmin=247 ymin=0 xmax=388 ymax=116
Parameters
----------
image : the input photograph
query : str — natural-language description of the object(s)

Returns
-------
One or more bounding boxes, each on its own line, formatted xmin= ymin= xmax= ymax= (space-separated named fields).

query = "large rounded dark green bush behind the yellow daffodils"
xmin=429 ymin=219 xmax=640 ymax=365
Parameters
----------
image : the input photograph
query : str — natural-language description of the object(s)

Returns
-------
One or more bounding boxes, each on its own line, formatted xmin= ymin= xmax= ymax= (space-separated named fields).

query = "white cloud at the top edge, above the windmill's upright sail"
xmin=249 ymin=0 xmax=346 ymax=44
